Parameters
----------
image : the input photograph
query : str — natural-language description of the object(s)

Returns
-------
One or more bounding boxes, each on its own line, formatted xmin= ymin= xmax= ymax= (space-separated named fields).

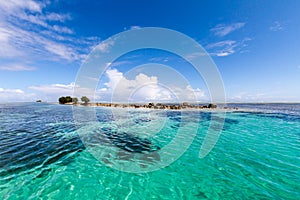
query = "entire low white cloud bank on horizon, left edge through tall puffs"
xmin=0 ymin=69 xmax=208 ymax=102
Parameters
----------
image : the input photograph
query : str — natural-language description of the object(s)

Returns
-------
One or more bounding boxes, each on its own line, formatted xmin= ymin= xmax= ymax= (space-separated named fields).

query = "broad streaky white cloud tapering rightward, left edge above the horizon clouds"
xmin=0 ymin=22 xmax=81 ymax=61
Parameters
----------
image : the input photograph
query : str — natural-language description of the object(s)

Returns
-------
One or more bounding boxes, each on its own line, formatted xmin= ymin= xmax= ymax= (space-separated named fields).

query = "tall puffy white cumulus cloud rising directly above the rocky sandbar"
xmin=96 ymin=69 xmax=207 ymax=102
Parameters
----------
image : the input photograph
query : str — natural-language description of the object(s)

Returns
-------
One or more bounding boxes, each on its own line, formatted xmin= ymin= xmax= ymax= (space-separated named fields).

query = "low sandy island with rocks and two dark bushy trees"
xmin=58 ymin=96 xmax=238 ymax=110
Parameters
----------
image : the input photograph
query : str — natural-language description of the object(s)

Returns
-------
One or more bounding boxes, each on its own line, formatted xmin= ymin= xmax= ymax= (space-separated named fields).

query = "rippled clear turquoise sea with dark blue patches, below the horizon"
xmin=0 ymin=103 xmax=300 ymax=199
